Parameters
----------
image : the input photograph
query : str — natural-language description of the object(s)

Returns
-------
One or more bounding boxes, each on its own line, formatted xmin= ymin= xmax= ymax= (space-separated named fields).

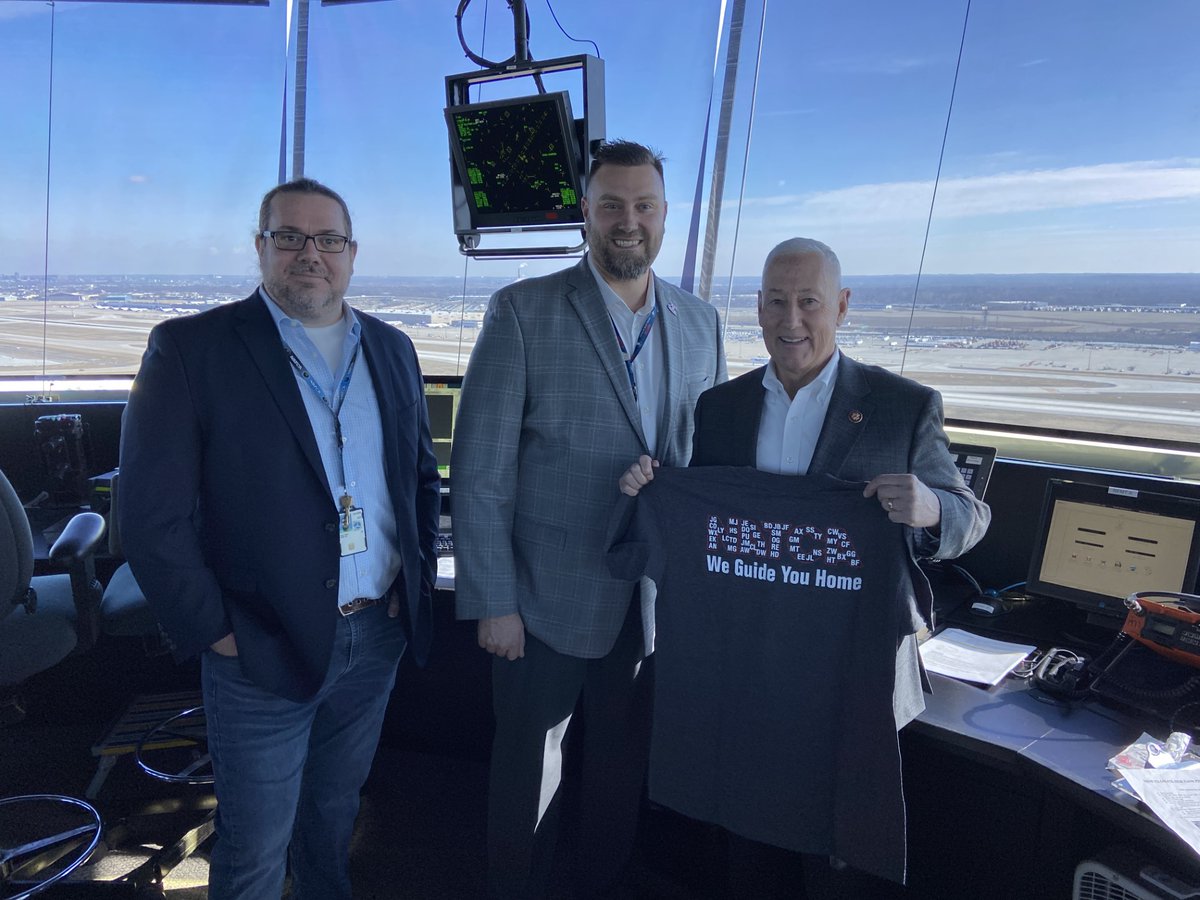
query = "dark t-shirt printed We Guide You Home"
xmin=610 ymin=467 xmax=912 ymax=881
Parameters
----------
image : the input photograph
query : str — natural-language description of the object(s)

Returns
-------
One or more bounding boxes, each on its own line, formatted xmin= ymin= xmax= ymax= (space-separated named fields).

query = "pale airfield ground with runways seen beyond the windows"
xmin=0 ymin=301 xmax=1200 ymax=442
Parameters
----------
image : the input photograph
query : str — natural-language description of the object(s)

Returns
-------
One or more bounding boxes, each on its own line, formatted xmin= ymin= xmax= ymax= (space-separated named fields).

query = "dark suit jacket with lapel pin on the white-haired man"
xmin=691 ymin=354 xmax=991 ymax=728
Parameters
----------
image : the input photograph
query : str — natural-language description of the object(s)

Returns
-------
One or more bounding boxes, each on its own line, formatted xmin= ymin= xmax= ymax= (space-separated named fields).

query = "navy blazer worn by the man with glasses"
xmin=119 ymin=293 xmax=440 ymax=700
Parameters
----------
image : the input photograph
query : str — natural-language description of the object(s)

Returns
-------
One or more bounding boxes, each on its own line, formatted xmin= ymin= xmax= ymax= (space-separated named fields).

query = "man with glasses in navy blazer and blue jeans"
xmin=120 ymin=179 xmax=439 ymax=900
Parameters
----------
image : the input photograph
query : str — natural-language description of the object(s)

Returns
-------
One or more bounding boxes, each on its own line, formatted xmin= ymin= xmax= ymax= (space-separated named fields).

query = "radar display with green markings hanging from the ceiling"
xmin=445 ymin=91 xmax=583 ymax=229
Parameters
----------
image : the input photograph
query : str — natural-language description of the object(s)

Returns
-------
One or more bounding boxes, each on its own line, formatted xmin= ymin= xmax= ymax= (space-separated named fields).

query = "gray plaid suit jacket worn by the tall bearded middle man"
xmin=450 ymin=259 xmax=726 ymax=659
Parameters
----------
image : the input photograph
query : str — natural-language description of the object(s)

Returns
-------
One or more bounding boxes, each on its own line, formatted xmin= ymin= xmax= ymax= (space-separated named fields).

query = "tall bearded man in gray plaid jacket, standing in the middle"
xmin=451 ymin=142 xmax=725 ymax=899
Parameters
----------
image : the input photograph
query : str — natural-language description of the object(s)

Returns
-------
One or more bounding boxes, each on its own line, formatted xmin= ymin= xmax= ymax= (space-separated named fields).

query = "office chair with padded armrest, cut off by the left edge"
xmin=0 ymin=472 xmax=104 ymax=724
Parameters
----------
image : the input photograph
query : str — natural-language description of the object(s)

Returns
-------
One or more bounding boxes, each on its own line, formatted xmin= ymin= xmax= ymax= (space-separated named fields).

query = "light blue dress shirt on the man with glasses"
xmin=259 ymin=288 xmax=400 ymax=606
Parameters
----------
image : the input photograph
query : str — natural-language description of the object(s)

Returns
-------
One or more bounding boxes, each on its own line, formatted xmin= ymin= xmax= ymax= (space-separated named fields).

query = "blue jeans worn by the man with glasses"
xmin=200 ymin=605 xmax=404 ymax=900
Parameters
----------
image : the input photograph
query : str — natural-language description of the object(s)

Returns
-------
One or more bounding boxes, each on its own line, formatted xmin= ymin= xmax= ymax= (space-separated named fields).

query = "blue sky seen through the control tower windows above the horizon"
xmin=0 ymin=0 xmax=1200 ymax=276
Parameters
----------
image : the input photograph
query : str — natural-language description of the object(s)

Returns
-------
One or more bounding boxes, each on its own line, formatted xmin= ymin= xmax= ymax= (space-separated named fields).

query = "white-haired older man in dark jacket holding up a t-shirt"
xmin=620 ymin=238 xmax=991 ymax=898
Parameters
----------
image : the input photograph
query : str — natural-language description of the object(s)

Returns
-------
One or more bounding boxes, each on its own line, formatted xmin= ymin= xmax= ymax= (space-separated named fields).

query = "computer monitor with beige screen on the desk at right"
xmin=1026 ymin=479 xmax=1200 ymax=629
